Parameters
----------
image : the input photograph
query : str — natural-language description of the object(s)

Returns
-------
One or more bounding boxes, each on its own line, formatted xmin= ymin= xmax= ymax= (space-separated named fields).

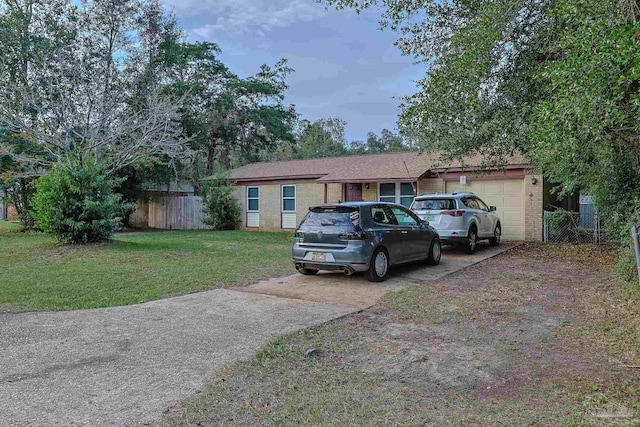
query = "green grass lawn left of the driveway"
xmin=0 ymin=226 xmax=293 ymax=312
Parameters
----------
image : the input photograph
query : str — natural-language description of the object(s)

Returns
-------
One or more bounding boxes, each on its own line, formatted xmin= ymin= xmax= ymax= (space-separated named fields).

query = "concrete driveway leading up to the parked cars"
xmin=0 ymin=244 xmax=512 ymax=426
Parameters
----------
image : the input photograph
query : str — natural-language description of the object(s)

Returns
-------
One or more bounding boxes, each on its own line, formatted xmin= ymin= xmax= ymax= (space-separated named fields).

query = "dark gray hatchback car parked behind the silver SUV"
xmin=293 ymin=202 xmax=442 ymax=282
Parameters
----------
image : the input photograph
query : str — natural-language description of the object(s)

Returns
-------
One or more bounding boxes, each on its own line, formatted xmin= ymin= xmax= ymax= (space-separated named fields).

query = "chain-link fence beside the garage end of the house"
xmin=543 ymin=210 xmax=609 ymax=245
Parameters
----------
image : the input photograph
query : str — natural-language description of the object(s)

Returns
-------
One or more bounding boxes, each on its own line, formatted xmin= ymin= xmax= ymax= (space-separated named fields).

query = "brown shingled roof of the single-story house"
xmin=229 ymin=152 xmax=523 ymax=183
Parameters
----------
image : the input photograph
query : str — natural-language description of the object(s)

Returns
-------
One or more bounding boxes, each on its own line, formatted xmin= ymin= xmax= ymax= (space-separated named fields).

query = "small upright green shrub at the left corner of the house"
xmin=200 ymin=173 xmax=240 ymax=230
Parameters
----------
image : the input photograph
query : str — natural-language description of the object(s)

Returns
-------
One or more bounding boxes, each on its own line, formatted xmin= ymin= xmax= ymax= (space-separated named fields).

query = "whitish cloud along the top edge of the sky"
xmin=164 ymin=0 xmax=327 ymax=39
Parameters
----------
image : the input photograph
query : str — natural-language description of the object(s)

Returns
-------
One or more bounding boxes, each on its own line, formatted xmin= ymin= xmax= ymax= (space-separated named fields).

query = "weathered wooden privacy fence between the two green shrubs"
xmin=129 ymin=195 xmax=209 ymax=230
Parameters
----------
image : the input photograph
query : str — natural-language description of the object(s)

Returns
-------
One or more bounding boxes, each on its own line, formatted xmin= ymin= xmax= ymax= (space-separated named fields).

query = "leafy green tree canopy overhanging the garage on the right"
xmin=325 ymin=0 xmax=640 ymax=247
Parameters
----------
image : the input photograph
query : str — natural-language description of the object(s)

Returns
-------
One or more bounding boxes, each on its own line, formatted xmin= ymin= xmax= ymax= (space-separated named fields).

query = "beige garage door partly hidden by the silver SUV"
xmin=446 ymin=179 xmax=524 ymax=240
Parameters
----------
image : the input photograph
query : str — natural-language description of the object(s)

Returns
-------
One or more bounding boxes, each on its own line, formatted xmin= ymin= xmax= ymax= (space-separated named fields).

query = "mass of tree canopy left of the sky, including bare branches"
xmin=0 ymin=0 xmax=297 ymax=179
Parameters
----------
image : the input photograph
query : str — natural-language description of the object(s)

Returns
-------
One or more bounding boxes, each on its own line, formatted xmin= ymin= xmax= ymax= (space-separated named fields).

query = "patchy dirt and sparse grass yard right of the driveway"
xmin=166 ymin=244 xmax=640 ymax=426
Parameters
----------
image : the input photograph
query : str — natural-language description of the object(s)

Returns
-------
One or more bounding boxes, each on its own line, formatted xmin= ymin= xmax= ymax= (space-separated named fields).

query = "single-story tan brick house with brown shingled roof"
xmin=229 ymin=152 xmax=544 ymax=240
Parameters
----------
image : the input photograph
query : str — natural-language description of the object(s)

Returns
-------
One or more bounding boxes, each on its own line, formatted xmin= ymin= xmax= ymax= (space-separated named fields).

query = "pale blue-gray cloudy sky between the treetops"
xmin=163 ymin=0 xmax=426 ymax=141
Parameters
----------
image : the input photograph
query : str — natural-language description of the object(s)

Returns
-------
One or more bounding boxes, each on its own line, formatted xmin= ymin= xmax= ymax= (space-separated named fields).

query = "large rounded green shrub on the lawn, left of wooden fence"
xmin=33 ymin=162 xmax=123 ymax=243
